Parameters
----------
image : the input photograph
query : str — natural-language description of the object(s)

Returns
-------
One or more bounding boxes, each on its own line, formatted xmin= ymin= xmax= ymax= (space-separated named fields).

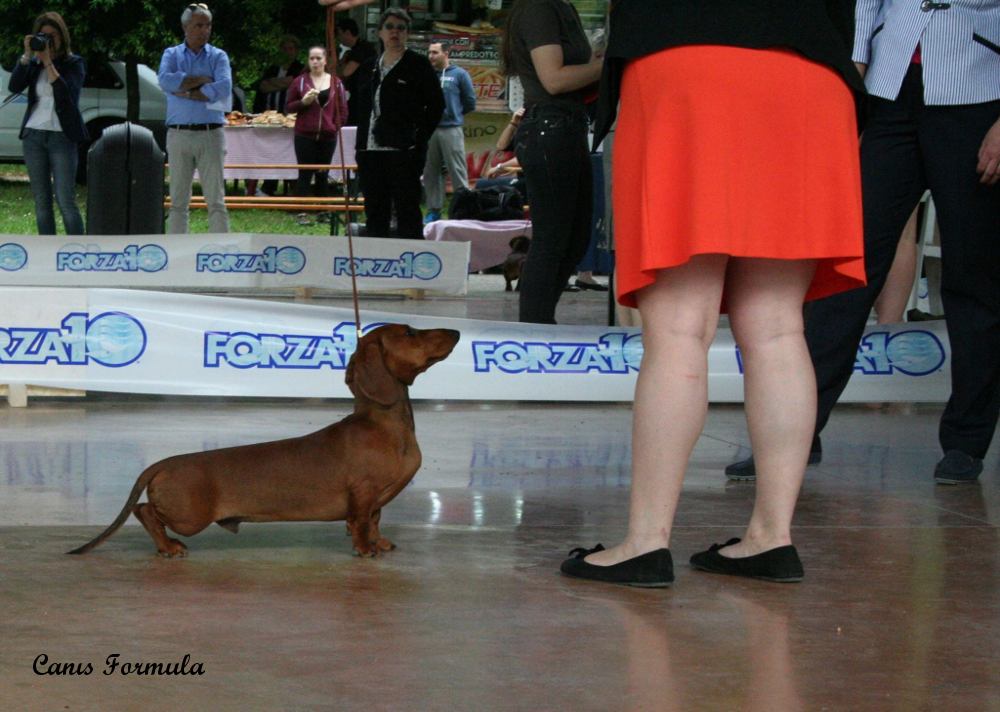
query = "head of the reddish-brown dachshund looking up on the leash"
xmin=345 ymin=324 xmax=459 ymax=406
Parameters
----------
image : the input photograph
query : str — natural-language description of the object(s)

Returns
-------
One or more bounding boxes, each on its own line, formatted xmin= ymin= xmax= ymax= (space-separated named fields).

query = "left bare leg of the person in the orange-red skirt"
xmin=586 ymin=255 xmax=729 ymax=566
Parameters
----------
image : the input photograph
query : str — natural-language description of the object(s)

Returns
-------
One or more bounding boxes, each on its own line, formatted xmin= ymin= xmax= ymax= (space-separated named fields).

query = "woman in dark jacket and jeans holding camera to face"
xmin=8 ymin=12 xmax=88 ymax=235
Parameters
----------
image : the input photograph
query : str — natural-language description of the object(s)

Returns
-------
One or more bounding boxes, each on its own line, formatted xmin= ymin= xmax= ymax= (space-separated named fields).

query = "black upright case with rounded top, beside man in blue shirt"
xmin=87 ymin=121 xmax=164 ymax=235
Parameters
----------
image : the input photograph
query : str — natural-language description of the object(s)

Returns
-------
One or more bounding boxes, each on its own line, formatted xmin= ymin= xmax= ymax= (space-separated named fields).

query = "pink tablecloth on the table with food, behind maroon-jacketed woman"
xmin=224 ymin=126 xmax=357 ymax=180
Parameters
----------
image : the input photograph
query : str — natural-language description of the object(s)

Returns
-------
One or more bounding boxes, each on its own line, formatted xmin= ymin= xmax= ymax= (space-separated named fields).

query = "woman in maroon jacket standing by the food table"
xmin=285 ymin=46 xmax=347 ymax=218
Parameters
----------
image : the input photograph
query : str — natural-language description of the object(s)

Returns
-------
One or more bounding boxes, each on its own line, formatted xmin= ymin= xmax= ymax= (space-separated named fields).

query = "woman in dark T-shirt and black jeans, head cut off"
xmin=502 ymin=0 xmax=601 ymax=324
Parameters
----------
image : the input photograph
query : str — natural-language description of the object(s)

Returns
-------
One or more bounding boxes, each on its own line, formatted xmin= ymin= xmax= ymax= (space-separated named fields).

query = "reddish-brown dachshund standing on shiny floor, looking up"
xmin=68 ymin=324 xmax=459 ymax=557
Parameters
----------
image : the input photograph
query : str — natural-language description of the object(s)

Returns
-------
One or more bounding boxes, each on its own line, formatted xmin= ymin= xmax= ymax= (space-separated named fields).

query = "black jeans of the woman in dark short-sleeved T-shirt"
xmin=515 ymin=105 xmax=594 ymax=324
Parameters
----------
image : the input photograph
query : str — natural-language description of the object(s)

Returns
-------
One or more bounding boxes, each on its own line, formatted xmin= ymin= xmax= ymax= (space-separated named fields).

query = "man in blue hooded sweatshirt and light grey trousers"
xmin=424 ymin=42 xmax=476 ymax=224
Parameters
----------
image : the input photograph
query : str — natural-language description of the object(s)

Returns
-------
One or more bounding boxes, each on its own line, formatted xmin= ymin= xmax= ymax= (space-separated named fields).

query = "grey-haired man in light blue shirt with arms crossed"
xmin=159 ymin=3 xmax=233 ymax=233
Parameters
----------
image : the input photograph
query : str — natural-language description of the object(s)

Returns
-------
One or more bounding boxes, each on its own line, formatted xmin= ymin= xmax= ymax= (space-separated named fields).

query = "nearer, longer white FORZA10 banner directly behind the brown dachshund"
xmin=0 ymin=288 xmax=950 ymax=402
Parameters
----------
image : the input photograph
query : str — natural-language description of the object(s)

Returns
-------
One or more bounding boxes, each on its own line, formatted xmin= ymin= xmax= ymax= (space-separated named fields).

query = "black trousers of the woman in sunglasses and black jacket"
xmin=358 ymin=148 xmax=427 ymax=240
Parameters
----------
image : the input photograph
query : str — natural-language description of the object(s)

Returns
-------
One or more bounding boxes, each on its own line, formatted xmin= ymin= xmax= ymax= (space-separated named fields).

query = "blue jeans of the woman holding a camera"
xmin=22 ymin=129 xmax=87 ymax=235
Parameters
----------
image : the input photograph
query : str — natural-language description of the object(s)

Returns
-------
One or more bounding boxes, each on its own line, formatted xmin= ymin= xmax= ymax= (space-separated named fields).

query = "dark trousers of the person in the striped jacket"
xmin=806 ymin=65 xmax=1000 ymax=458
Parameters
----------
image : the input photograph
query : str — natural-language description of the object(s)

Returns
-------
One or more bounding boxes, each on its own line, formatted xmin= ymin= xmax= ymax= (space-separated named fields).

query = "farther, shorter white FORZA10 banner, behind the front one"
xmin=0 ymin=233 xmax=470 ymax=295
